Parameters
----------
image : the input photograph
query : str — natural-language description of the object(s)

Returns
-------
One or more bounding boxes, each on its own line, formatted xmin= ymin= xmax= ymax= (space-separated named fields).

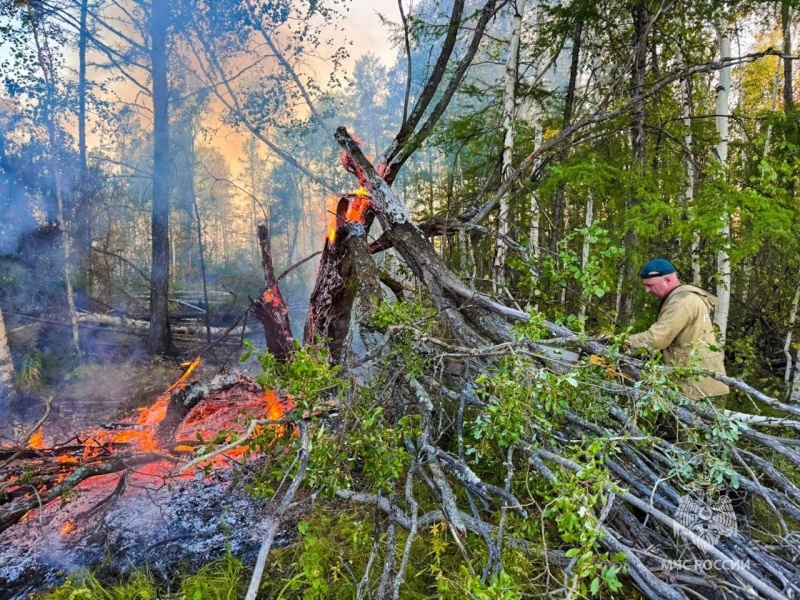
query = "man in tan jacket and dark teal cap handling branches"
xmin=628 ymin=258 xmax=730 ymax=399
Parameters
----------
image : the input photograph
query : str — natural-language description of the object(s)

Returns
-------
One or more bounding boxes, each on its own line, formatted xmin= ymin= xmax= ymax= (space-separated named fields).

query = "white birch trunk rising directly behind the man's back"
xmin=714 ymin=18 xmax=731 ymax=344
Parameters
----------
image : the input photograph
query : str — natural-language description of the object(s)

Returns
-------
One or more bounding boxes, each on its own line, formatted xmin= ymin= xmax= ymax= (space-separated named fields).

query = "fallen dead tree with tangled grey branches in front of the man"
xmin=302 ymin=128 xmax=800 ymax=600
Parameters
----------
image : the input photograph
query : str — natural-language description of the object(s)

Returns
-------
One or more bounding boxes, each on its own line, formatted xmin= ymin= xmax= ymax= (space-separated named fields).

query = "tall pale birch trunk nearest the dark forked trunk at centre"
xmin=492 ymin=0 xmax=525 ymax=289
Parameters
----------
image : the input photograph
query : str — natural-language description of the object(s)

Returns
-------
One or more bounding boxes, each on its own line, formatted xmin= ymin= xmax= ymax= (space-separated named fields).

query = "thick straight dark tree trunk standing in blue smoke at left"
xmin=147 ymin=0 xmax=172 ymax=354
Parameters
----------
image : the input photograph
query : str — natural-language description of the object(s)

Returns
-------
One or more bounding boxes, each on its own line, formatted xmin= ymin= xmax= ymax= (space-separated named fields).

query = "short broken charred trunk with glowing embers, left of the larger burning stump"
xmin=252 ymin=225 xmax=294 ymax=362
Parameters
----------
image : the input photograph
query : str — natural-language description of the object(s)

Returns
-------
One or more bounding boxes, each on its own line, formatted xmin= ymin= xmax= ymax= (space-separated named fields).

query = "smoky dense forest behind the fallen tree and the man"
xmin=0 ymin=0 xmax=800 ymax=597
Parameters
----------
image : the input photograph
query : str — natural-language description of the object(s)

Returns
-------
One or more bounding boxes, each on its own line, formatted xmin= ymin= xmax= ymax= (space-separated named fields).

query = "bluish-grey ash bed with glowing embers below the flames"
xmin=0 ymin=462 xmax=292 ymax=600
